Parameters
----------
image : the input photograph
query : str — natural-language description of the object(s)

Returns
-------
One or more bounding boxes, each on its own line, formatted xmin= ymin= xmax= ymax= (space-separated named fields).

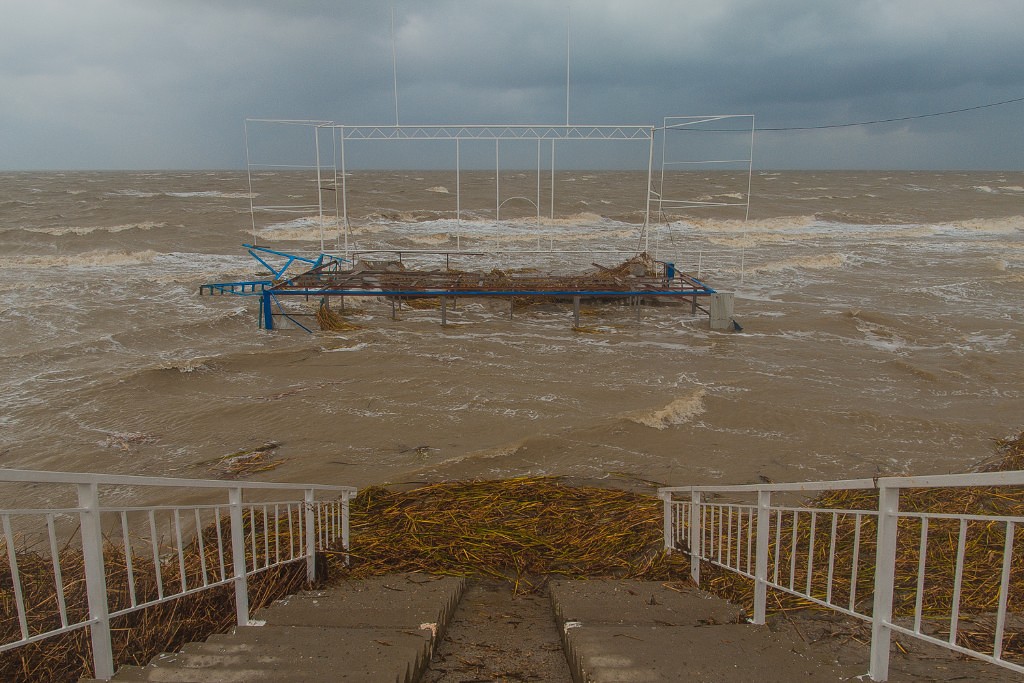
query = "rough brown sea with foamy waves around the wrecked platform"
xmin=0 ymin=171 xmax=1024 ymax=505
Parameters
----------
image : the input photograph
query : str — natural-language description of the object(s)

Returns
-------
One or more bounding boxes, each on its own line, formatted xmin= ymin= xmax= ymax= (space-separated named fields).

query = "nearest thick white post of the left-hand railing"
xmin=78 ymin=483 xmax=114 ymax=681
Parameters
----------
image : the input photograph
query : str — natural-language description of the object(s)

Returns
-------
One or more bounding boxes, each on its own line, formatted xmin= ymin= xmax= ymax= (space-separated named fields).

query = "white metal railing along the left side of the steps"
xmin=0 ymin=469 xmax=356 ymax=679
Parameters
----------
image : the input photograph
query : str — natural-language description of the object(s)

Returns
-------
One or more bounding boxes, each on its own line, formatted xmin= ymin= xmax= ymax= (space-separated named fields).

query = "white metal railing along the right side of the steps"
xmin=658 ymin=471 xmax=1024 ymax=681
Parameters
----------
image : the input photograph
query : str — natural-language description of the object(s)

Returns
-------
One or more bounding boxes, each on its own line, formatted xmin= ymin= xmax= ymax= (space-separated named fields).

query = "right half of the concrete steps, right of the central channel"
xmin=550 ymin=581 xmax=863 ymax=683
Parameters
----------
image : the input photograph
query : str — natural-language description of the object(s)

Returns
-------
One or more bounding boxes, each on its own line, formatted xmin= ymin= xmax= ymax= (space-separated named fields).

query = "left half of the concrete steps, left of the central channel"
xmin=89 ymin=574 xmax=465 ymax=683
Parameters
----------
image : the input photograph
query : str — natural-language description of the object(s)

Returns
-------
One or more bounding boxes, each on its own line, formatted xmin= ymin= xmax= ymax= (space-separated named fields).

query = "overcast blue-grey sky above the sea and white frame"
xmin=0 ymin=0 xmax=1024 ymax=170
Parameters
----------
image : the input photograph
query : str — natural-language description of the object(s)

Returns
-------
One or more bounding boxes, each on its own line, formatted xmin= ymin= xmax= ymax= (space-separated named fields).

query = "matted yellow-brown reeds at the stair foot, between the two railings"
xmin=332 ymin=477 xmax=683 ymax=593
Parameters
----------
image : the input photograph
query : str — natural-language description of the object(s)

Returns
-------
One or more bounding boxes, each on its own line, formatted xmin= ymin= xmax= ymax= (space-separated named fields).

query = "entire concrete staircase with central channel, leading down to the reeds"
xmin=81 ymin=573 xmax=999 ymax=683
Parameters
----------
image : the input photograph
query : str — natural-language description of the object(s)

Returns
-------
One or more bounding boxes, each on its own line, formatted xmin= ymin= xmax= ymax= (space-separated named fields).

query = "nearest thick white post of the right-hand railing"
xmin=867 ymin=486 xmax=899 ymax=681
